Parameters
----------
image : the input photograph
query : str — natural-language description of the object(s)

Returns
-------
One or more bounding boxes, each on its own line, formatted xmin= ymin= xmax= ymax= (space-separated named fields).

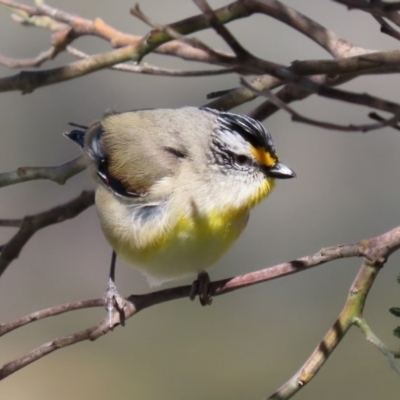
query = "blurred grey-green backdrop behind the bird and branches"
xmin=0 ymin=0 xmax=400 ymax=400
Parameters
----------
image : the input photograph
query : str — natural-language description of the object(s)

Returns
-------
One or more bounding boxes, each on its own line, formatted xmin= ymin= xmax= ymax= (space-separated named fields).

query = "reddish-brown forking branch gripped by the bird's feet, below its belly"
xmin=0 ymin=227 xmax=400 ymax=382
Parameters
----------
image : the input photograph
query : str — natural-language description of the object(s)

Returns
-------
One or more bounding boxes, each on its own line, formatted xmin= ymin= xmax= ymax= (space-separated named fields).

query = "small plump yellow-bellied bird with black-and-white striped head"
xmin=66 ymin=106 xmax=296 ymax=304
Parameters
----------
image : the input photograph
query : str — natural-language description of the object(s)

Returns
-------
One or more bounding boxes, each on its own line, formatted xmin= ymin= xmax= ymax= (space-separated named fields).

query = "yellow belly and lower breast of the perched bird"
xmin=112 ymin=208 xmax=249 ymax=284
